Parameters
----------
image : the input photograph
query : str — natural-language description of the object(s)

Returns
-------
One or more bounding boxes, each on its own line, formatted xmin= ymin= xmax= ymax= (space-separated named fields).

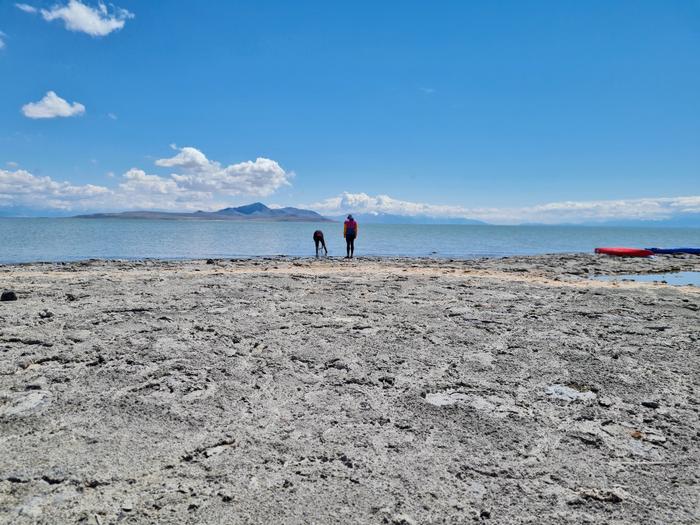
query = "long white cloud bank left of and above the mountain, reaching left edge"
xmin=0 ymin=148 xmax=292 ymax=210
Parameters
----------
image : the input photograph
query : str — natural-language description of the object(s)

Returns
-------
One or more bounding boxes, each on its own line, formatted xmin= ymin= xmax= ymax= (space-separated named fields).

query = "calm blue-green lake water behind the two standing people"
xmin=0 ymin=218 xmax=700 ymax=263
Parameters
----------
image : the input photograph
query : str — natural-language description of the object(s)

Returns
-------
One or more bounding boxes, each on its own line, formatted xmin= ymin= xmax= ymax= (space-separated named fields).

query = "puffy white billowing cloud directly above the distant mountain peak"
xmin=156 ymin=147 xmax=294 ymax=197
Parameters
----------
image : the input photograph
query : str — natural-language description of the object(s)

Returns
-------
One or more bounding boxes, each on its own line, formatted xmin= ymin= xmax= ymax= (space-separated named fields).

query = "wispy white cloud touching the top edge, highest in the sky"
xmin=38 ymin=0 xmax=134 ymax=36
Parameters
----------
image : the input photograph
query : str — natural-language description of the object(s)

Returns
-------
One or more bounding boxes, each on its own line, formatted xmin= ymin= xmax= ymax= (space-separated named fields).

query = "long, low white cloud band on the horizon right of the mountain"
xmin=306 ymin=193 xmax=700 ymax=224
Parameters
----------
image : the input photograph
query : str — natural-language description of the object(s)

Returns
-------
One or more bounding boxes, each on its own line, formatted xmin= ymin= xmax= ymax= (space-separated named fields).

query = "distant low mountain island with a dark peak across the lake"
xmin=75 ymin=202 xmax=333 ymax=222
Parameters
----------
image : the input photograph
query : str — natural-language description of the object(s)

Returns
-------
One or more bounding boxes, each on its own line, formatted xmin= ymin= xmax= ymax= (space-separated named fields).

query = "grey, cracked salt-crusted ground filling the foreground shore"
xmin=0 ymin=255 xmax=700 ymax=524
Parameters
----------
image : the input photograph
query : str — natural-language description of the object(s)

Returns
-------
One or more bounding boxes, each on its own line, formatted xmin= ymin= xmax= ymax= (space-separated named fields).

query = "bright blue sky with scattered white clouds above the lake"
xmin=0 ymin=0 xmax=700 ymax=222
